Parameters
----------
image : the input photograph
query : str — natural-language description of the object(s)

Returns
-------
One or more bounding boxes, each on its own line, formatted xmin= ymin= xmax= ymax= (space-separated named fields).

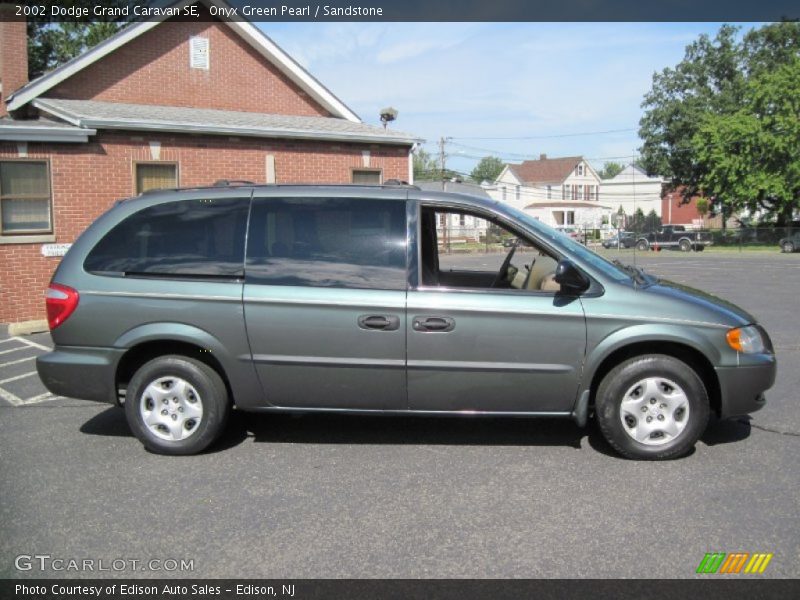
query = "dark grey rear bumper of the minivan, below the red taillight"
xmin=36 ymin=346 xmax=124 ymax=404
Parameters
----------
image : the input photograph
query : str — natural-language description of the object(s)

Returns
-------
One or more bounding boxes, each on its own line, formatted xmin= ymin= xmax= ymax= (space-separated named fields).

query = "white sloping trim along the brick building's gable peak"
xmin=6 ymin=0 xmax=361 ymax=123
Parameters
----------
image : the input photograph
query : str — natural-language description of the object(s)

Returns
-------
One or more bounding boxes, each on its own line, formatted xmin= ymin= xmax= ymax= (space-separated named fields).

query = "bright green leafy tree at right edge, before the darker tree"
xmin=692 ymin=56 xmax=800 ymax=225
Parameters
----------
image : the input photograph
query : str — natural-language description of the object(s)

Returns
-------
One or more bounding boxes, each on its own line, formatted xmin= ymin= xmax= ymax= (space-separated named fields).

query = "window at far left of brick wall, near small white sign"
xmin=0 ymin=160 xmax=53 ymax=236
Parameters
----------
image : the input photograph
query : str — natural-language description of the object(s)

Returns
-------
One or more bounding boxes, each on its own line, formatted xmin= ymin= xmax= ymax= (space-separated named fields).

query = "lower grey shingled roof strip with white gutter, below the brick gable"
xmin=33 ymin=98 xmax=421 ymax=145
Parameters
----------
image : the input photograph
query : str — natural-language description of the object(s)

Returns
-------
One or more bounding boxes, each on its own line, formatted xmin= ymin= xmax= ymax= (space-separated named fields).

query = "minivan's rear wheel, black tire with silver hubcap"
xmin=125 ymin=356 xmax=230 ymax=454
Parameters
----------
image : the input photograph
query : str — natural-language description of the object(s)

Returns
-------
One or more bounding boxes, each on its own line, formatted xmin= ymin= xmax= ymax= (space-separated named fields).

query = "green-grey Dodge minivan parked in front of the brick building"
xmin=37 ymin=185 xmax=776 ymax=459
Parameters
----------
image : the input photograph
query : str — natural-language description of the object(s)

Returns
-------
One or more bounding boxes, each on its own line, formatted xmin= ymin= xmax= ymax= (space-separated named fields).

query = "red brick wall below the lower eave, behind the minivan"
xmin=0 ymin=133 xmax=408 ymax=323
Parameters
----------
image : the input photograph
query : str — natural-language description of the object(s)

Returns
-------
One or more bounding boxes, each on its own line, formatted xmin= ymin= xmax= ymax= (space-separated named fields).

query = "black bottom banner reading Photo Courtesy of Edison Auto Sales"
xmin=0 ymin=576 xmax=800 ymax=600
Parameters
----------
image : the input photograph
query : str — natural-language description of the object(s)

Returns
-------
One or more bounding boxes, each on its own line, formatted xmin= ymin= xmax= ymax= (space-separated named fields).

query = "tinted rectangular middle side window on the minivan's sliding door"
xmin=245 ymin=198 xmax=406 ymax=290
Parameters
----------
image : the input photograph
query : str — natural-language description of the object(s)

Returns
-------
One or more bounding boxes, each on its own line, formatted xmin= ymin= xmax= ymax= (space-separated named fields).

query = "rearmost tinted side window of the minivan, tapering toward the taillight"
xmin=84 ymin=198 xmax=249 ymax=278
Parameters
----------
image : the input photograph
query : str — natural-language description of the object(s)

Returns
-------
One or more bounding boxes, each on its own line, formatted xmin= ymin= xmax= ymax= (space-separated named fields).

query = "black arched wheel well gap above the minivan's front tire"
xmin=589 ymin=341 xmax=722 ymax=415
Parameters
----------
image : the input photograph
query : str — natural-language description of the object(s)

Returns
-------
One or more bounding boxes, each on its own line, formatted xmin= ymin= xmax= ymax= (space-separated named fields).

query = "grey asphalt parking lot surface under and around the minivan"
xmin=0 ymin=251 xmax=800 ymax=578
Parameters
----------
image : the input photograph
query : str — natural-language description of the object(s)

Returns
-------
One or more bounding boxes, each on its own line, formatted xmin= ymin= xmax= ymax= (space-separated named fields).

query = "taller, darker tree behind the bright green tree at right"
xmin=639 ymin=22 xmax=800 ymax=224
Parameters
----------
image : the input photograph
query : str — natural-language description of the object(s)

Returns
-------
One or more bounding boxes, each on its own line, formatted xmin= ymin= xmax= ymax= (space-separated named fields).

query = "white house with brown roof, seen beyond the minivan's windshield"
xmin=489 ymin=154 xmax=610 ymax=227
